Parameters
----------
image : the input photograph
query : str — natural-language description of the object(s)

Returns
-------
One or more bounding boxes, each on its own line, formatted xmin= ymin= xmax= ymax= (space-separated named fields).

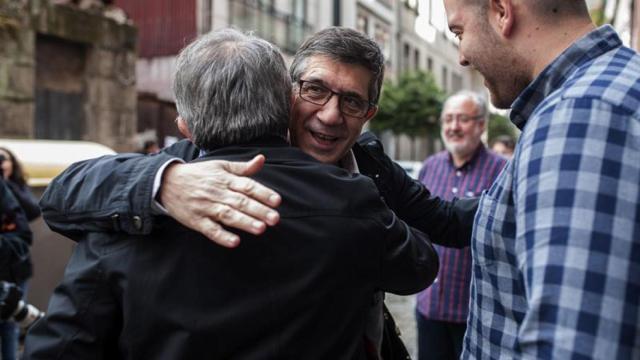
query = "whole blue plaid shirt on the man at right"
xmin=462 ymin=26 xmax=640 ymax=359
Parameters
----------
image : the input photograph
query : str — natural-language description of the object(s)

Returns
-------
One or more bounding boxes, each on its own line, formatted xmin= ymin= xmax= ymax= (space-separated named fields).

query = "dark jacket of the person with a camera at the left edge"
xmin=0 ymin=180 xmax=32 ymax=283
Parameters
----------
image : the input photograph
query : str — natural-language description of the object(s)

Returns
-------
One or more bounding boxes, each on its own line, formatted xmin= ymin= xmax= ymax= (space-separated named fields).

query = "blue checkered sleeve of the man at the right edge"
xmin=514 ymin=97 xmax=640 ymax=359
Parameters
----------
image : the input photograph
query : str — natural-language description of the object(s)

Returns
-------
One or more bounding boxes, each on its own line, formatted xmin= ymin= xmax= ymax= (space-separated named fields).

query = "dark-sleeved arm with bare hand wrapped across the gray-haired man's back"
xmin=40 ymin=140 xmax=280 ymax=247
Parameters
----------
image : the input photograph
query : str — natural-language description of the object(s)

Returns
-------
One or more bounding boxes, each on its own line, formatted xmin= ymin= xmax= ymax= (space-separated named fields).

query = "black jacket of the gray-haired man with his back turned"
xmin=25 ymin=141 xmax=438 ymax=359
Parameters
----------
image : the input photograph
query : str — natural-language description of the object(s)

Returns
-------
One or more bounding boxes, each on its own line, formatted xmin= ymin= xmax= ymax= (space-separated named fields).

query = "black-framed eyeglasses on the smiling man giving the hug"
xmin=298 ymin=80 xmax=375 ymax=118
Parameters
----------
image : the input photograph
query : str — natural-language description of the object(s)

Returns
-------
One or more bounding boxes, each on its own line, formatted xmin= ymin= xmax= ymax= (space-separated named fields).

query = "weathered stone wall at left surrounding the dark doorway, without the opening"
xmin=0 ymin=0 xmax=137 ymax=151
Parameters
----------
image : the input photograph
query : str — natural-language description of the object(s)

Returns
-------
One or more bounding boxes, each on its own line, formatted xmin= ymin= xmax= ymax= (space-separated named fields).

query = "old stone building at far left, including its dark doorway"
xmin=0 ymin=0 xmax=136 ymax=150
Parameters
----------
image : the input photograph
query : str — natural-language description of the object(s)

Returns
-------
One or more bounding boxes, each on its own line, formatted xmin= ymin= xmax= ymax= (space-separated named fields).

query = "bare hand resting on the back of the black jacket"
xmin=160 ymin=155 xmax=281 ymax=247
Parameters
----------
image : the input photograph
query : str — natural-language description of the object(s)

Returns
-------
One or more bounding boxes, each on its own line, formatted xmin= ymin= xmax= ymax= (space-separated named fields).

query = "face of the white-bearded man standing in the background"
xmin=441 ymin=97 xmax=486 ymax=159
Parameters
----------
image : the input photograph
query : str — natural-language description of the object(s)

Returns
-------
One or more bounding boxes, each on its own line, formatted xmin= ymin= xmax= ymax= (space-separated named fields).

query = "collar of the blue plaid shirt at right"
xmin=510 ymin=25 xmax=622 ymax=130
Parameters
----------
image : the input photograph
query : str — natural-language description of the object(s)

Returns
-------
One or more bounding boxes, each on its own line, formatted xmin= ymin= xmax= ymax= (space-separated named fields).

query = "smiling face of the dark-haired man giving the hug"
xmin=290 ymin=55 xmax=376 ymax=164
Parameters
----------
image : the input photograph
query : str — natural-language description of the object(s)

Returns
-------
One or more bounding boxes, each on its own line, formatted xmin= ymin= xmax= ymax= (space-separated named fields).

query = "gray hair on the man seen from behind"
xmin=173 ymin=29 xmax=291 ymax=150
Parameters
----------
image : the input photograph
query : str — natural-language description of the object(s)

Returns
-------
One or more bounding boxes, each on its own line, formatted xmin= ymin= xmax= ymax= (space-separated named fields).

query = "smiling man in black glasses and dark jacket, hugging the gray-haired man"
xmin=41 ymin=27 xmax=477 ymax=359
